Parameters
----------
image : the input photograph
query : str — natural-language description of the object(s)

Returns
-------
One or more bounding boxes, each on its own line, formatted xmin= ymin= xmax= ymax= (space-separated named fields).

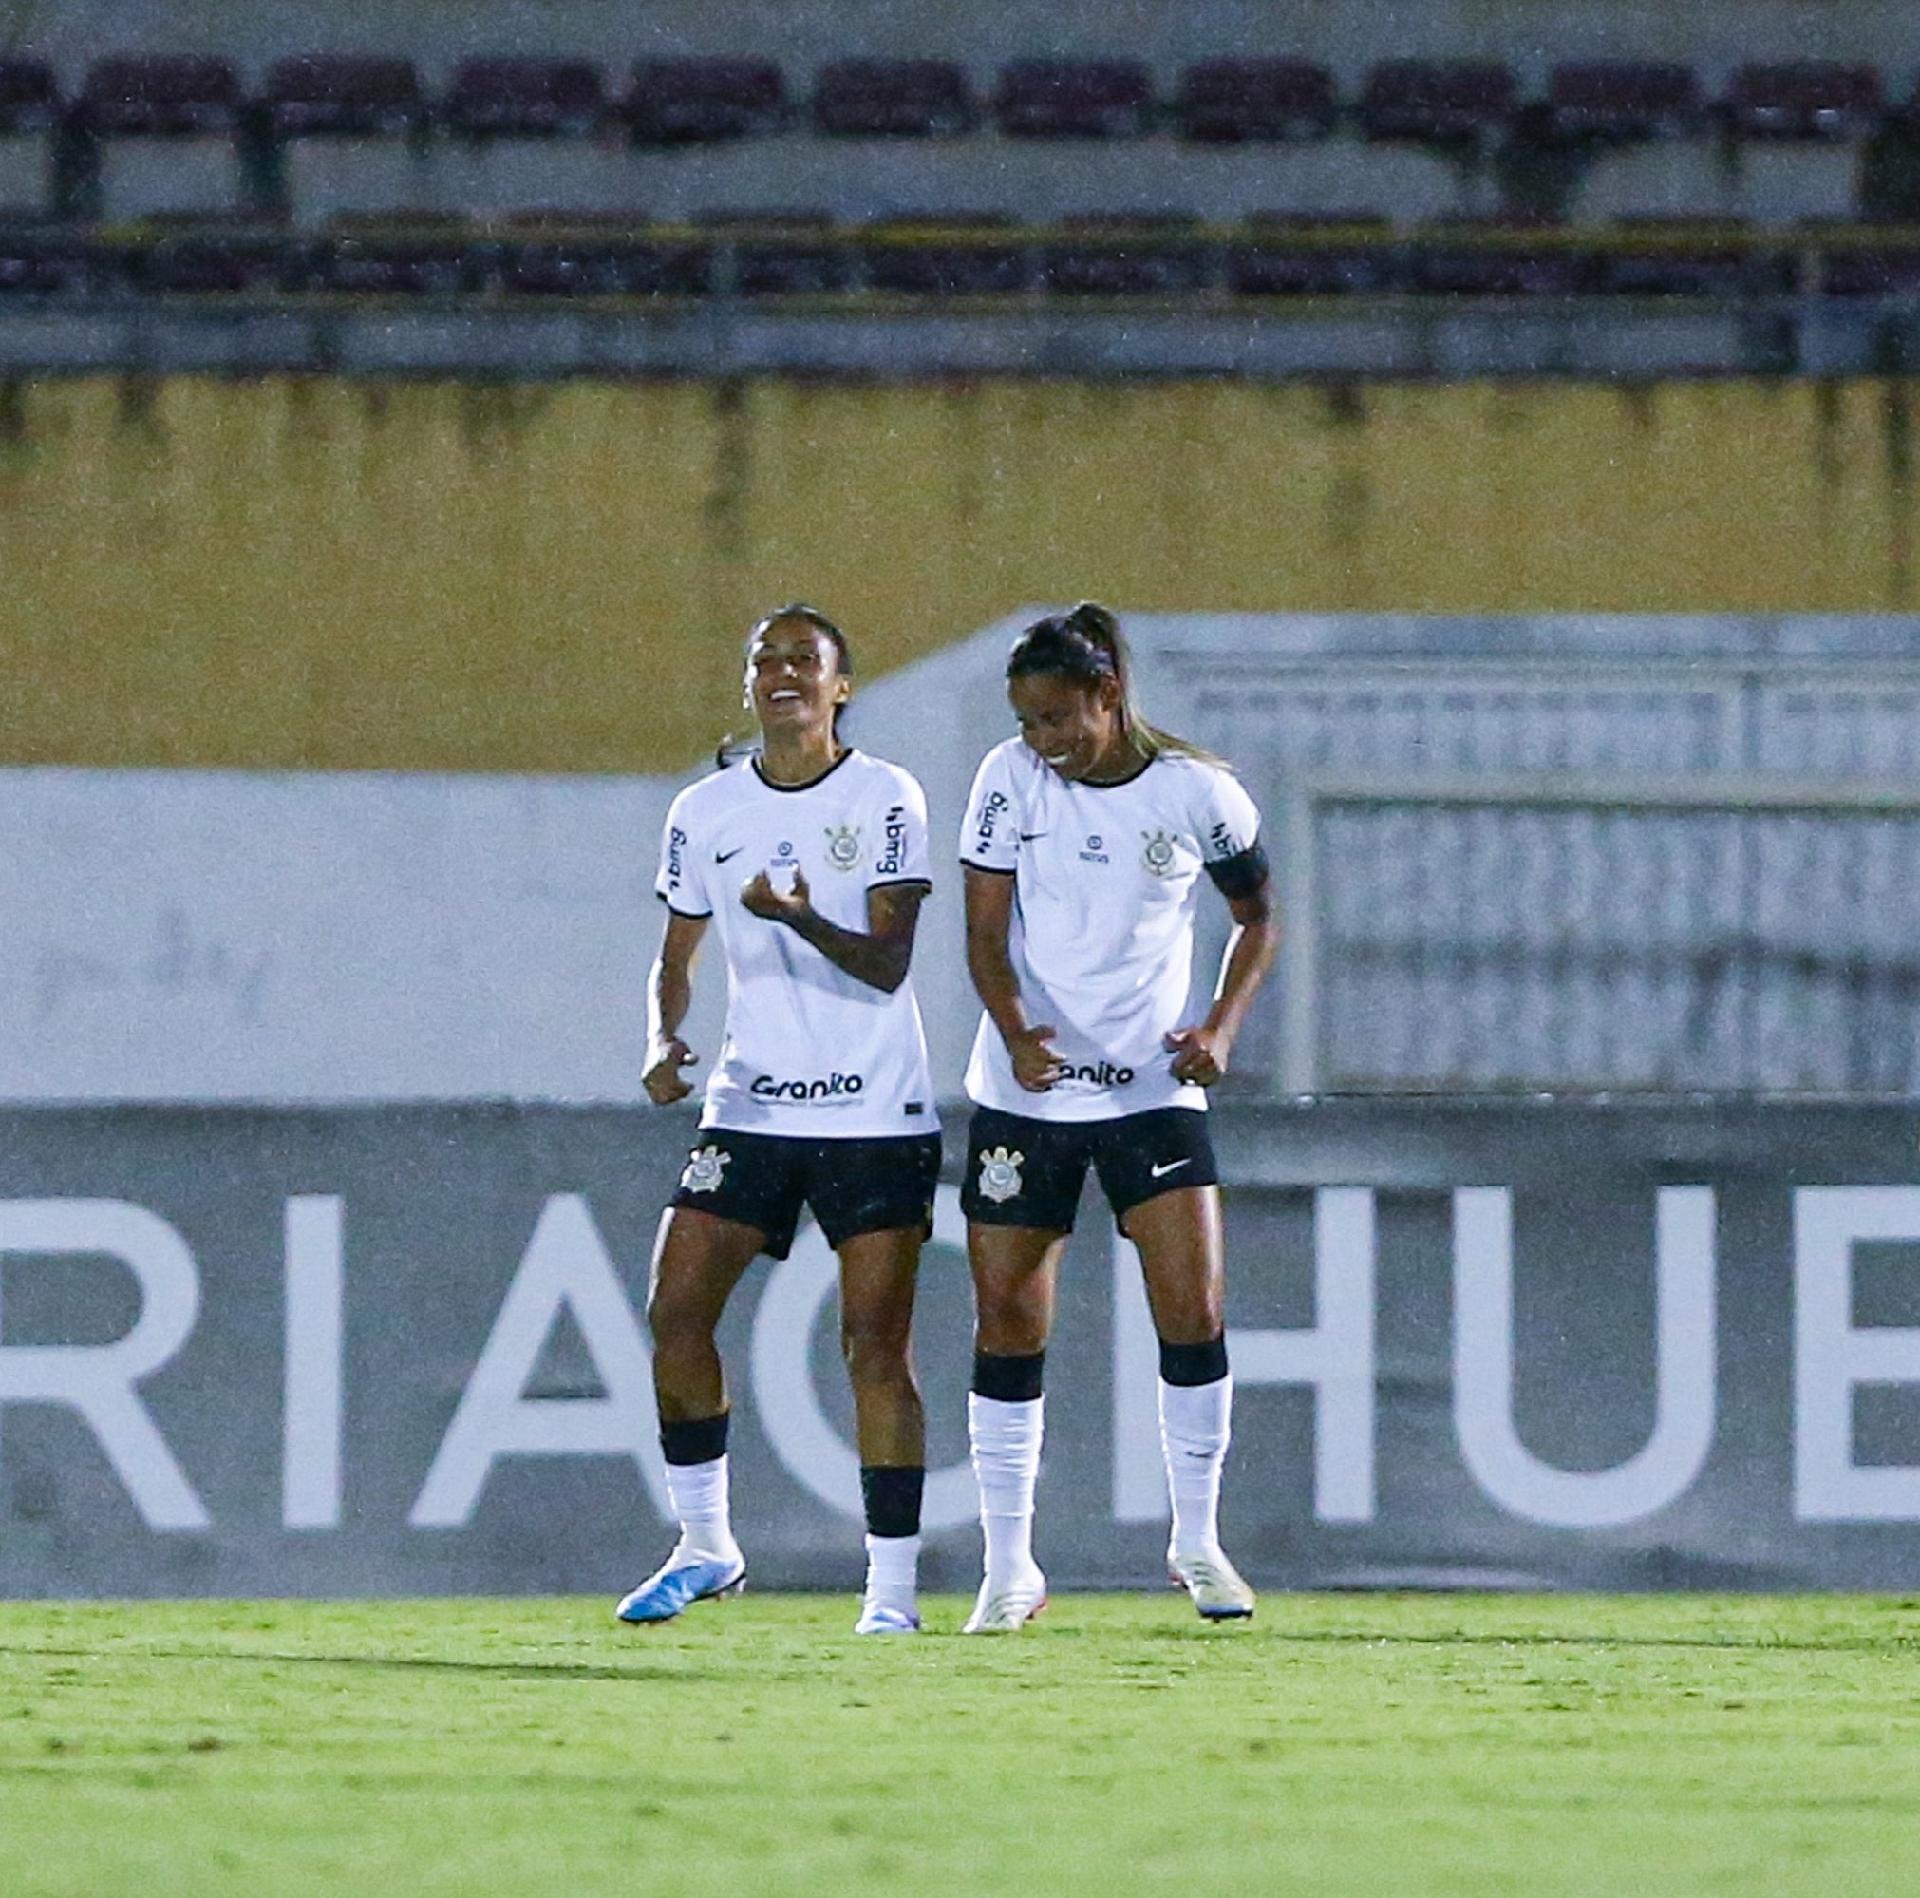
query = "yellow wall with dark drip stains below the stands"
xmin=0 ymin=378 xmax=1920 ymax=771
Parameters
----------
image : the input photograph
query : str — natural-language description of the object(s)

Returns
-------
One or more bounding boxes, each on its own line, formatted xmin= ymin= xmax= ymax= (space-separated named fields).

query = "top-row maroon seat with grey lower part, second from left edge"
xmin=69 ymin=54 xmax=248 ymax=219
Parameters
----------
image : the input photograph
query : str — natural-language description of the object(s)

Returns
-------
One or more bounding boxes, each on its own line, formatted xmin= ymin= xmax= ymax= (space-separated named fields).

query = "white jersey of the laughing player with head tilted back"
xmin=655 ymin=750 xmax=939 ymax=1140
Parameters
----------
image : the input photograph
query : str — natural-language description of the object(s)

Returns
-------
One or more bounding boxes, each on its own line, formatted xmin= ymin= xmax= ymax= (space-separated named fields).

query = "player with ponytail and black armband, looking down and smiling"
xmin=960 ymin=605 xmax=1279 ymax=1633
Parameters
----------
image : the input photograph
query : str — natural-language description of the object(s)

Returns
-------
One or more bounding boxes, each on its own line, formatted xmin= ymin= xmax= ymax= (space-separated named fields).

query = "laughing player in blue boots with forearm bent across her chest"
xmin=618 ymin=606 xmax=941 ymax=1635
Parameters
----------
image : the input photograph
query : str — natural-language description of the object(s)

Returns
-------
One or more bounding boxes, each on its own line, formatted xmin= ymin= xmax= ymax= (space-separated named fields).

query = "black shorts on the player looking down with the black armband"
xmin=960 ymin=1107 xmax=1219 ymax=1232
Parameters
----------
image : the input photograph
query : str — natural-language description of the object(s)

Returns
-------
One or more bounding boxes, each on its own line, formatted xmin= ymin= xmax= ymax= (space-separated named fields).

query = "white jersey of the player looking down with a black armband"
xmin=960 ymin=739 xmax=1260 ymax=1121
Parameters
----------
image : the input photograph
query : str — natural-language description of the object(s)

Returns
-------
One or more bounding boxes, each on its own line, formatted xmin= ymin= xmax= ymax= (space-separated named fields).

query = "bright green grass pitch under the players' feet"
xmin=0 ymin=1595 xmax=1920 ymax=1898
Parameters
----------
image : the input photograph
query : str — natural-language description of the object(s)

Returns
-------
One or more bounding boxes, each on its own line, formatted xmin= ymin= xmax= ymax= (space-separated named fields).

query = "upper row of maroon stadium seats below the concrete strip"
xmin=0 ymin=54 xmax=1916 ymax=144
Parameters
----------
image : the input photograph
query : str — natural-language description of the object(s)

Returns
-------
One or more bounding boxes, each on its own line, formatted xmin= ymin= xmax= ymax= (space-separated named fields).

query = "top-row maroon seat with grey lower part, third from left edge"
xmin=259 ymin=54 xmax=438 ymax=225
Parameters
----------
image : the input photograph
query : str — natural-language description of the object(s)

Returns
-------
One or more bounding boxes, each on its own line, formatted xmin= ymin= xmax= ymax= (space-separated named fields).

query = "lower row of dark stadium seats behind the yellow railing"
xmin=15 ymin=215 xmax=1920 ymax=299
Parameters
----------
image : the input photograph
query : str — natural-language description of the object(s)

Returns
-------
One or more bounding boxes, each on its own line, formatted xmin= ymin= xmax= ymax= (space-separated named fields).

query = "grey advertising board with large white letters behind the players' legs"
xmin=0 ymin=1098 xmax=1920 ymax=1597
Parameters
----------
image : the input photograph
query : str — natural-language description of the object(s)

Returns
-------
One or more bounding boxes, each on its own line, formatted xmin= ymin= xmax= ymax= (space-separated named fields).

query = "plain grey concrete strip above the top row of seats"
xmin=22 ymin=0 xmax=1920 ymax=79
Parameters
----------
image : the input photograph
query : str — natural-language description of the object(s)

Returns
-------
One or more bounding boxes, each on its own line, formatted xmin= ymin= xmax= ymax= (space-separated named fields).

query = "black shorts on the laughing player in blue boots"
xmin=668 ymin=1127 xmax=941 ymax=1259
